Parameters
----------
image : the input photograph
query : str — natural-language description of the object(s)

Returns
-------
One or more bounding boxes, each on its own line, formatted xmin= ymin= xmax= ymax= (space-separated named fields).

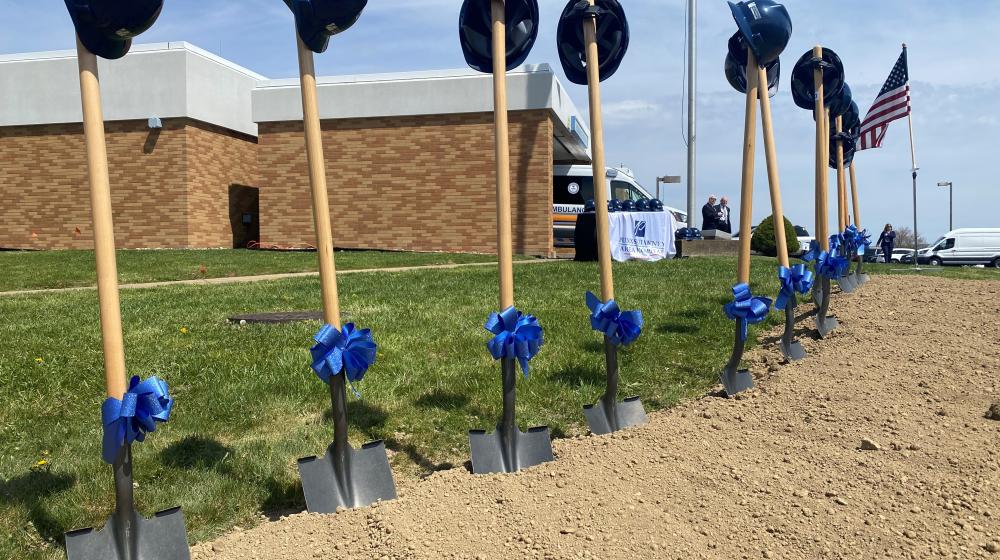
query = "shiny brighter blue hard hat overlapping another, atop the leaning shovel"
xmin=729 ymin=0 xmax=792 ymax=66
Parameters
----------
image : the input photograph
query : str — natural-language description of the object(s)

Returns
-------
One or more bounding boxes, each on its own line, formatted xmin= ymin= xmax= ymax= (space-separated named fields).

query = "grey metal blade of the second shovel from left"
xmin=299 ymin=441 xmax=396 ymax=513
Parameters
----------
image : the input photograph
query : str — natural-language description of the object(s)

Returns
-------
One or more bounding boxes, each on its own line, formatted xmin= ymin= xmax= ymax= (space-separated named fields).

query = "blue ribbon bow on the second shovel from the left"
xmin=309 ymin=323 xmax=378 ymax=397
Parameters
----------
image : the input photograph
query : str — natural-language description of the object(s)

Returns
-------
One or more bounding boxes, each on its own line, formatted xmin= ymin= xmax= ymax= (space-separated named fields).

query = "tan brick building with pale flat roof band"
xmin=0 ymin=43 xmax=589 ymax=255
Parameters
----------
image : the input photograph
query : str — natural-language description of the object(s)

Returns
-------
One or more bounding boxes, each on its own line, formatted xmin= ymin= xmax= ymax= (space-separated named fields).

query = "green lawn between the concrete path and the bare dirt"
xmin=0 ymin=255 xmax=944 ymax=560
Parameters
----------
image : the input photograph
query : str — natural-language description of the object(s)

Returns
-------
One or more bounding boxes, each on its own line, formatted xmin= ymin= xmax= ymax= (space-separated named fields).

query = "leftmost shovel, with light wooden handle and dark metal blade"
xmin=66 ymin=38 xmax=190 ymax=560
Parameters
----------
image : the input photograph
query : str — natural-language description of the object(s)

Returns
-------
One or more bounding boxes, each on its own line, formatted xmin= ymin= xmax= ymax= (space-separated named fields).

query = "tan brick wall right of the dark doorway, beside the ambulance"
xmin=258 ymin=111 xmax=553 ymax=256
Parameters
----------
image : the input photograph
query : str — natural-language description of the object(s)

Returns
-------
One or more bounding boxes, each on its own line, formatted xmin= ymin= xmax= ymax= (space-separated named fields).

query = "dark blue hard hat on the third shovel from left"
xmin=458 ymin=0 xmax=538 ymax=74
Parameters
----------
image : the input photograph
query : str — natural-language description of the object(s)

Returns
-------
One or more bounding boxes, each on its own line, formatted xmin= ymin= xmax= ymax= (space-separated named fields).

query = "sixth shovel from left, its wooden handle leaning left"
xmin=747 ymin=61 xmax=806 ymax=361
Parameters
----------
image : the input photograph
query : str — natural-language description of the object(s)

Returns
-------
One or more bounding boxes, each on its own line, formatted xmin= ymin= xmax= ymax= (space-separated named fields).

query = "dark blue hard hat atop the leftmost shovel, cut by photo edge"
xmin=65 ymin=0 xmax=163 ymax=59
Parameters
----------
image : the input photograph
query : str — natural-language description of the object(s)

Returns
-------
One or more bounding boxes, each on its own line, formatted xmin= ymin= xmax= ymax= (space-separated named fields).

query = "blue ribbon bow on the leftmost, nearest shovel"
xmin=101 ymin=376 xmax=174 ymax=464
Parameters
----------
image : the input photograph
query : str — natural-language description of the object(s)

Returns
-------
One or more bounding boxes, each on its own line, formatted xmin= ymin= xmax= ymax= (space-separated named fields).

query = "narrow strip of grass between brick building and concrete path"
xmin=0 ymin=249 xmax=508 ymax=292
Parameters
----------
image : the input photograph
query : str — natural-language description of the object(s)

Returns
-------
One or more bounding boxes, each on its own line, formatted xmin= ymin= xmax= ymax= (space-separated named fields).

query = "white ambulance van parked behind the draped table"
xmin=552 ymin=165 xmax=687 ymax=247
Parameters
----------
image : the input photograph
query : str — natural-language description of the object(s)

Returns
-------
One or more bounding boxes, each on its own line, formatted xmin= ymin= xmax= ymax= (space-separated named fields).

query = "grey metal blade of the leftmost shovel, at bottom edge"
xmin=66 ymin=508 xmax=191 ymax=560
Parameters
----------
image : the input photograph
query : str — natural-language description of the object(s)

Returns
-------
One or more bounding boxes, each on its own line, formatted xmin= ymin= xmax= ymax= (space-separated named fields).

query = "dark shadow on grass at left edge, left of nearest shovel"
xmin=0 ymin=471 xmax=76 ymax=546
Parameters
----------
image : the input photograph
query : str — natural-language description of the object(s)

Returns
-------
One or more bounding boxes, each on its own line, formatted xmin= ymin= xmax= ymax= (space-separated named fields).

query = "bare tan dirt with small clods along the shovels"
xmin=193 ymin=277 xmax=1000 ymax=560
